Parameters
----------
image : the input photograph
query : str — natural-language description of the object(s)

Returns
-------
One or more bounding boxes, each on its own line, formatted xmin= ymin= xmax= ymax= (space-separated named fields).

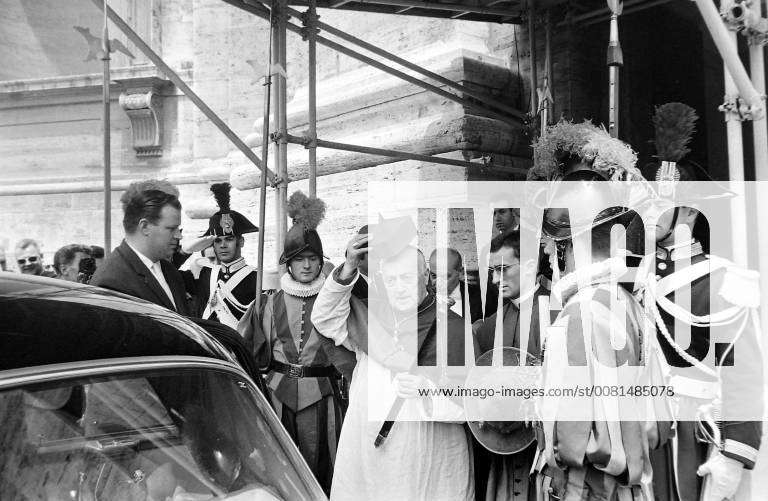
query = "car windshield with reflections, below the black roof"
xmin=0 ymin=369 xmax=322 ymax=501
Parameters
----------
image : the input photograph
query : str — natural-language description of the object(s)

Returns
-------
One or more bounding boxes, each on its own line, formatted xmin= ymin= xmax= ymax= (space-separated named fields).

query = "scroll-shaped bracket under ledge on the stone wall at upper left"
xmin=119 ymin=88 xmax=163 ymax=157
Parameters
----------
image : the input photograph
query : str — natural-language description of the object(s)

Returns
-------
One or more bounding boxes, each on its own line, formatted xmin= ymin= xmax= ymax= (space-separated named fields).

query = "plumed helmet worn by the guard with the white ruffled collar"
xmin=280 ymin=191 xmax=325 ymax=264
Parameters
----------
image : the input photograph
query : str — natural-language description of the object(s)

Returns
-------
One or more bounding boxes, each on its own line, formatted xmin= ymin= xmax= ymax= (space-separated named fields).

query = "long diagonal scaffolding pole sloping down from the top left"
xmin=92 ymin=0 xmax=276 ymax=184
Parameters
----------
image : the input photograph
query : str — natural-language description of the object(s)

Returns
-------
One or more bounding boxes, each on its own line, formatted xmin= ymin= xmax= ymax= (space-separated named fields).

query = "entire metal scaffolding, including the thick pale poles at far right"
xmin=92 ymin=0 xmax=768 ymax=312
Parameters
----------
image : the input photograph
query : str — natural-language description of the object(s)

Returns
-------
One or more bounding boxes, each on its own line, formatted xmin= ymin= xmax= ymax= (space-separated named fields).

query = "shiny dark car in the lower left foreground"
xmin=0 ymin=273 xmax=325 ymax=501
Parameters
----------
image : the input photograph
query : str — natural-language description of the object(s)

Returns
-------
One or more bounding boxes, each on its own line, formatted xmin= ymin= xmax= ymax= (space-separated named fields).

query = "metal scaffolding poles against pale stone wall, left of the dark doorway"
xmin=92 ymin=0 xmax=528 ymax=304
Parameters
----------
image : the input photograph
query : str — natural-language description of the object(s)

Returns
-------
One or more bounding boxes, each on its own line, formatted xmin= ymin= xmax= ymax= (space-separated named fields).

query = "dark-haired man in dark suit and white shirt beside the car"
xmin=90 ymin=183 xmax=190 ymax=315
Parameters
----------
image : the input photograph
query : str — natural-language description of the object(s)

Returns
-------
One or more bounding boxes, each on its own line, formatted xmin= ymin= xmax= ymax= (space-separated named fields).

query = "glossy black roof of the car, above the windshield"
xmin=0 ymin=272 xmax=236 ymax=371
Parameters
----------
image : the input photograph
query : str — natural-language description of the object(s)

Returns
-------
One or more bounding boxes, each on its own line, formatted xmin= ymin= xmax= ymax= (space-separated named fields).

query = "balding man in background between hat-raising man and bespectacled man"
xmin=429 ymin=247 xmax=483 ymax=322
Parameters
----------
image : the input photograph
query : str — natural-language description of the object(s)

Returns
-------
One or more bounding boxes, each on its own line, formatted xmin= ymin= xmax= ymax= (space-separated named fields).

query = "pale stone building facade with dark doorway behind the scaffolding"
xmin=0 ymin=0 xmax=727 ymax=265
